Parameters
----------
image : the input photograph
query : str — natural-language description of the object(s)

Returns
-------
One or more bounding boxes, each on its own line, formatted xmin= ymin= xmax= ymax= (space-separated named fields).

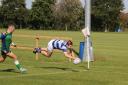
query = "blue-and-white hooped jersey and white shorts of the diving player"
xmin=48 ymin=39 xmax=68 ymax=52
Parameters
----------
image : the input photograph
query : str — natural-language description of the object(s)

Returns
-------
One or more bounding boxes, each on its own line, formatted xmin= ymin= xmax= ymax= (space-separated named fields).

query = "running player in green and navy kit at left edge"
xmin=0 ymin=24 xmax=26 ymax=73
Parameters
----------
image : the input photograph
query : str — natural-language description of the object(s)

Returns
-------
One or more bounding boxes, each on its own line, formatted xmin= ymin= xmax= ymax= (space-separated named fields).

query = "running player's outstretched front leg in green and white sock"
xmin=7 ymin=52 xmax=26 ymax=72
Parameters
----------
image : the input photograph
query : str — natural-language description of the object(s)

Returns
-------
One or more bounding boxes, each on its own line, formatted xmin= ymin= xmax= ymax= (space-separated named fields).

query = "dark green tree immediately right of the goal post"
xmin=92 ymin=0 xmax=123 ymax=31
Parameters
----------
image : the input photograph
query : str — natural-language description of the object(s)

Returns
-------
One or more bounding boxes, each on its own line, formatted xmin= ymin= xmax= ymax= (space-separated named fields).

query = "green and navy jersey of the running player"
xmin=0 ymin=33 xmax=12 ymax=52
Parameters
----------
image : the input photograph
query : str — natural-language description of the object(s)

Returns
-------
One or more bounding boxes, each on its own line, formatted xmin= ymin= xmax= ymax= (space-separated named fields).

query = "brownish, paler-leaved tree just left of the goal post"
xmin=53 ymin=0 xmax=83 ymax=30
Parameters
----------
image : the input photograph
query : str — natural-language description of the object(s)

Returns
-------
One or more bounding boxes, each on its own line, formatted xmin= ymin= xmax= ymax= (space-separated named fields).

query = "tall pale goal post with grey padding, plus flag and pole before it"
xmin=82 ymin=0 xmax=93 ymax=69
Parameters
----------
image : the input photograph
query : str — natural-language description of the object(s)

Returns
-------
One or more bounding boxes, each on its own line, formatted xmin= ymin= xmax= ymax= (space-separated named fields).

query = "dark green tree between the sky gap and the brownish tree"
xmin=30 ymin=0 xmax=54 ymax=29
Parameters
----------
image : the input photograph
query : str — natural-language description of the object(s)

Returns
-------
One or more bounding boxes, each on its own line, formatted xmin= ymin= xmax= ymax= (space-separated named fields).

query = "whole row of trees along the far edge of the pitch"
xmin=0 ymin=0 xmax=124 ymax=31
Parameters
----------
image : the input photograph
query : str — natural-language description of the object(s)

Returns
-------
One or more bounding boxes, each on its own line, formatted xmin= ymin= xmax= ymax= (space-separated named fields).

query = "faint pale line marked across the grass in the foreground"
xmin=0 ymin=69 xmax=88 ymax=78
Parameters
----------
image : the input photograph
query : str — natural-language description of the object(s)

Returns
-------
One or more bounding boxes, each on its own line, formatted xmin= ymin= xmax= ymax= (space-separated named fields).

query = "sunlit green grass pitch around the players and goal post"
xmin=0 ymin=30 xmax=128 ymax=85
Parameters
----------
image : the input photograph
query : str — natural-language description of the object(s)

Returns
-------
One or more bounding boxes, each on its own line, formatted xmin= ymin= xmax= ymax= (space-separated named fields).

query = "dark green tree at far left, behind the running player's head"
xmin=1 ymin=0 xmax=27 ymax=28
